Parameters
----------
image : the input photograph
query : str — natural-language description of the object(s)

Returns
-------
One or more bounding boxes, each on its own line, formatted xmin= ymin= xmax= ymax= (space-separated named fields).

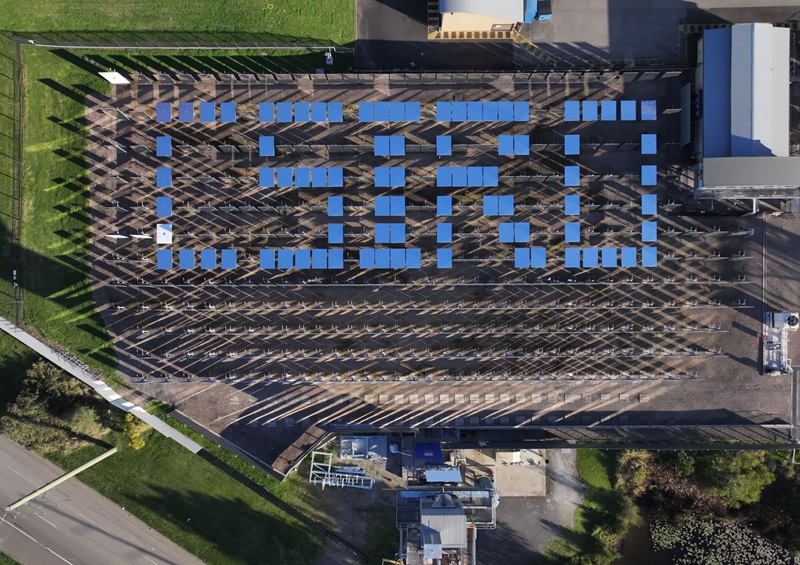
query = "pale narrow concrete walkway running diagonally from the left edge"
xmin=0 ymin=317 xmax=203 ymax=453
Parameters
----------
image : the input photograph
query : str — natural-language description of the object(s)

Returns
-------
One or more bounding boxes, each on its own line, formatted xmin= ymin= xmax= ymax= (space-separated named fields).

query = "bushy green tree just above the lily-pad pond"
xmin=695 ymin=451 xmax=775 ymax=508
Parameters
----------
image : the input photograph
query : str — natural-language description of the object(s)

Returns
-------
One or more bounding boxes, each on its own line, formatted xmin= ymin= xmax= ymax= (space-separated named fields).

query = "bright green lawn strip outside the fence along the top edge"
xmin=0 ymin=0 xmax=355 ymax=45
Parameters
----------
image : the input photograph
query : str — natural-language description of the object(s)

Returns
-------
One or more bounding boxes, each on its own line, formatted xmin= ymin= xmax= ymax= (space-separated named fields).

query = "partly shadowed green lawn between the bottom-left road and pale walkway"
xmin=47 ymin=432 xmax=323 ymax=564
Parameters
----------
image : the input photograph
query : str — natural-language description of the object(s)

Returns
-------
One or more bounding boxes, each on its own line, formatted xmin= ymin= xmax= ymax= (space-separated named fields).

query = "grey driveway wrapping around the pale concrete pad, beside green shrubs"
xmin=478 ymin=449 xmax=584 ymax=563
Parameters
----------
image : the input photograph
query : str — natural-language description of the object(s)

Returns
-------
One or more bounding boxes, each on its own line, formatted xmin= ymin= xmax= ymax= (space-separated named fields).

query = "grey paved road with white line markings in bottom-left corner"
xmin=0 ymin=436 xmax=202 ymax=565
